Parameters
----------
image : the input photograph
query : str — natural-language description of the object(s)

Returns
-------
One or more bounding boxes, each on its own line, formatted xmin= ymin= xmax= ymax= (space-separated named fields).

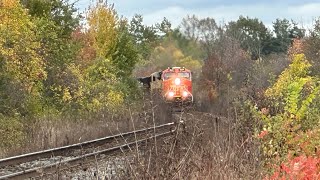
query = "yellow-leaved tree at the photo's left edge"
xmin=0 ymin=0 xmax=47 ymax=115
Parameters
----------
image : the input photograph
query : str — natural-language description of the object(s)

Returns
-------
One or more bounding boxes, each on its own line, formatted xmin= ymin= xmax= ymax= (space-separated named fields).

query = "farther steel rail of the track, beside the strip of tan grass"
xmin=0 ymin=123 xmax=174 ymax=168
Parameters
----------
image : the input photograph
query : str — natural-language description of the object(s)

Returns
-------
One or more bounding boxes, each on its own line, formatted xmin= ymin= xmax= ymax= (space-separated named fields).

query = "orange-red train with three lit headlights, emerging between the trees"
xmin=138 ymin=67 xmax=193 ymax=105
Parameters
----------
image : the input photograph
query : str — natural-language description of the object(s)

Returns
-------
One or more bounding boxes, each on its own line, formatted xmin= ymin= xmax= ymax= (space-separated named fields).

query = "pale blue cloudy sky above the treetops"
xmin=76 ymin=0 xmax=320 ymax=28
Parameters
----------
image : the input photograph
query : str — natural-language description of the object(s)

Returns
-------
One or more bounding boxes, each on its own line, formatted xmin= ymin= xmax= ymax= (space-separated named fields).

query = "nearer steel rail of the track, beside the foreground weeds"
xmin=0 ymin=130 xmax=175 ymax=180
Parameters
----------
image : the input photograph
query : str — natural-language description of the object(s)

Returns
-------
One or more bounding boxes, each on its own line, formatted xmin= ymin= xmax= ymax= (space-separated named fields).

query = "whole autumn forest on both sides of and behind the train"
xmin=0 ymin=0 xmax=320 ymax=179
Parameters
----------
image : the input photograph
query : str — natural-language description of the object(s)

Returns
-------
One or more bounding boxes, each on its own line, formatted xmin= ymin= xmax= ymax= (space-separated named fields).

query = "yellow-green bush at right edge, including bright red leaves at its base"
xmin=255 ymin=54 xmax=320 ymax=179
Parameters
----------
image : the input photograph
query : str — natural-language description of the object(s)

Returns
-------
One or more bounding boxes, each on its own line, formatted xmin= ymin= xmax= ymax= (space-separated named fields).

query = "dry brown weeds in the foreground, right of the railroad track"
xmin=122 ymin=106 xmax=260 ymax=179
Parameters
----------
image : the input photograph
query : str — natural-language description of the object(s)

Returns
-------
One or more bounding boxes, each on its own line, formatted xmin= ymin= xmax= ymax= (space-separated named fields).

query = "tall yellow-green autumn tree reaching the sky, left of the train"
xmin=85 ymin=2 xmax=139 ymax=110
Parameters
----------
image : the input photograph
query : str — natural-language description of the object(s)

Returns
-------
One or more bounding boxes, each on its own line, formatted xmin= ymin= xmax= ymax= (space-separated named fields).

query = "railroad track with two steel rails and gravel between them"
xmin=0 ymin=123 xmax=175 ymax=180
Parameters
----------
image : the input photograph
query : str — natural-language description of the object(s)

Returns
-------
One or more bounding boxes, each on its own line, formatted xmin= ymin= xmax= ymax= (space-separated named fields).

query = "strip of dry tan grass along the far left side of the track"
xmin=0 ymin=93 xmax=171 ymax=158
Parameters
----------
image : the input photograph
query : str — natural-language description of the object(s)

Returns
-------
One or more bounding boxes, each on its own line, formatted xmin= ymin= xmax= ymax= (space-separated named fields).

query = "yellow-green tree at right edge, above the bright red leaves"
xmin=258 ymin=54 xmax=320 ymax=166
